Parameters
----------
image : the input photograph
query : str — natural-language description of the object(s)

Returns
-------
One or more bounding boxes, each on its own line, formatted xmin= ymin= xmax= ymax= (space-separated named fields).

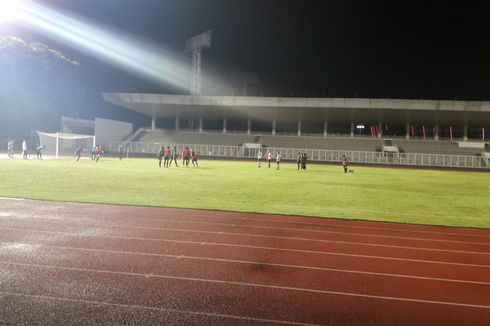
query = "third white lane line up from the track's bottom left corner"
xmin=0 ymin=241 xmax=490 ymax=285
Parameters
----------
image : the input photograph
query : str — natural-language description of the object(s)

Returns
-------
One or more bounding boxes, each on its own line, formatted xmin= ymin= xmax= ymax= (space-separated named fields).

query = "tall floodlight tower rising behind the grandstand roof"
xmin=185 ymin=30 xmax=212 ymax=95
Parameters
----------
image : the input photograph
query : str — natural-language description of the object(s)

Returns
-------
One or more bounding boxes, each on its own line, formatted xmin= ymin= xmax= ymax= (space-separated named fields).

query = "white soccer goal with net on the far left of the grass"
xmin=37 ymin=131 xmax=95 ymax=159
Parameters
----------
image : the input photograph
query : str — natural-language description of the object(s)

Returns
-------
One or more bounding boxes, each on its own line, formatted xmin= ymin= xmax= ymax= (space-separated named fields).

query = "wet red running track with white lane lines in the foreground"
xmin=0 ymin=198 xmax=490 ymax=325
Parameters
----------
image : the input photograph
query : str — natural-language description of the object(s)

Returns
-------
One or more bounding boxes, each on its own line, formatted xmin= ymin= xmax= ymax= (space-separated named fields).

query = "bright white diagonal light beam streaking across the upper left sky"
xmin=14 ymin=0 xmax=190 ymax=91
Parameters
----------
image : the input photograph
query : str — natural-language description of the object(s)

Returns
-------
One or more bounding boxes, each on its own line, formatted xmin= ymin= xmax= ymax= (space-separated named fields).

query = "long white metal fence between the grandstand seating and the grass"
xmin=108 ymin=142 xmax=490 ymax=169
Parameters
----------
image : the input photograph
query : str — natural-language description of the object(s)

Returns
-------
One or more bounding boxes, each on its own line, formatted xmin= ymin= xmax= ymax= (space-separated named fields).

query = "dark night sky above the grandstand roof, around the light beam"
xmin=3 ymin=0 xmax=490 ymax=100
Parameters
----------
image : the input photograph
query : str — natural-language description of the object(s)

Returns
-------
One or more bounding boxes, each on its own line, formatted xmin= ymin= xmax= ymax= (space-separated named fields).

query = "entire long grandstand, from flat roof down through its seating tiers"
xmin=103 ymin=93 xmax=490 ymax=167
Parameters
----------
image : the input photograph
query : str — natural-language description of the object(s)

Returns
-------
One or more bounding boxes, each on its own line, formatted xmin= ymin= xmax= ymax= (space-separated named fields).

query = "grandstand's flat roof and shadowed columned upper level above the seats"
xmin=103 ymin=93 xmax=490 ymax=140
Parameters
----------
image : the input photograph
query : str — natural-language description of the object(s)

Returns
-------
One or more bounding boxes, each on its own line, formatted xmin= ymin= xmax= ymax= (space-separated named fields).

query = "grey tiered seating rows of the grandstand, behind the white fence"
xmin=131 ymin=129 xmax=481 ymax=155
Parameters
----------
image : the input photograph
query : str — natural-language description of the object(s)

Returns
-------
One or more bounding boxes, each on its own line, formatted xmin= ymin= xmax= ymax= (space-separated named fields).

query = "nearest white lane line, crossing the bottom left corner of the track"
xmin=0 ymin=291 xmax=320 ymax=326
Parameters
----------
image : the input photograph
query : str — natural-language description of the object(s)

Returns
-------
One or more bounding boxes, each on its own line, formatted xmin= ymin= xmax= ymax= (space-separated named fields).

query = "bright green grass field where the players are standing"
xmin=0 ymin=158 xmax=490 ymax=228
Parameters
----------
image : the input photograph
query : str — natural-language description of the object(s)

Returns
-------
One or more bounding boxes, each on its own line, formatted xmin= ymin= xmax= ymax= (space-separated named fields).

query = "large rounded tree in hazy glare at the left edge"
xmin=0 ymin=37 xmax=86 ymax=139
